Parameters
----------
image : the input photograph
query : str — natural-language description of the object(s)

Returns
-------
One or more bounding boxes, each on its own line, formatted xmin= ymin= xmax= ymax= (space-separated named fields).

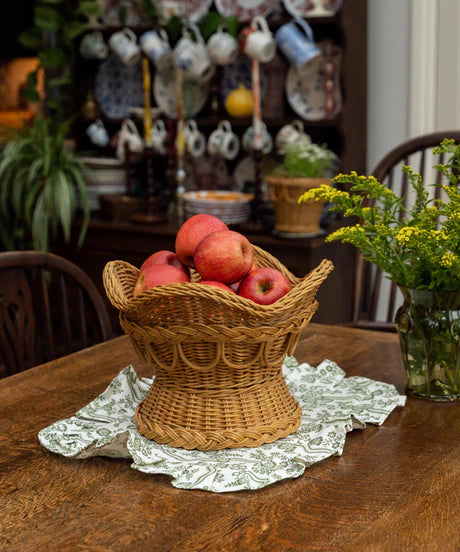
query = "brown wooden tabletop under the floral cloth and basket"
xmin=0 ymin=324 xmax=460 ymax=552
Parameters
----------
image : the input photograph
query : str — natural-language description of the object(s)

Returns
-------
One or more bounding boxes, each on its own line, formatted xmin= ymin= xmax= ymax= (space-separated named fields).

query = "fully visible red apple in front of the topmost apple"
xmin=194 ymin=229 xmax=254 ymax=284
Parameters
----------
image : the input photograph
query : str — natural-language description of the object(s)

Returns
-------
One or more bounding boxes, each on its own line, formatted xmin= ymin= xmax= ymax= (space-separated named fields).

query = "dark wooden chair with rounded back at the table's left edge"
xmin=0 ymin=251 xmax=112 ymax=377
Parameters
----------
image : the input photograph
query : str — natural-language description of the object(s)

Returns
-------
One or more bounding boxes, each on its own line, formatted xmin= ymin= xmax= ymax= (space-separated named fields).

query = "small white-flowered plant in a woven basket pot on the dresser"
xmin=265 ymin=135 xmax=338 ymax=236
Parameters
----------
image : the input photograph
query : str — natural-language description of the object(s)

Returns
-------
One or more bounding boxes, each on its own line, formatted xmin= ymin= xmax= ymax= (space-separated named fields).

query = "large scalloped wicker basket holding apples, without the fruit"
xmin=103 ymin=246 xmax=333 ymax=450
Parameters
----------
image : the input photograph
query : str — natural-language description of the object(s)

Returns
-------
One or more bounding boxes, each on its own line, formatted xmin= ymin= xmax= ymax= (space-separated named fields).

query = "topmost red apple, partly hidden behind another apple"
xmin=175 ymin=213 xmax=228 ymax=266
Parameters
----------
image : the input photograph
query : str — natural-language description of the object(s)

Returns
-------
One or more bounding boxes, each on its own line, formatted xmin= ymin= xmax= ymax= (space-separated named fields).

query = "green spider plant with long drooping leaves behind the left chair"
xmin=0 ymin=118 xmax=89 ymax=251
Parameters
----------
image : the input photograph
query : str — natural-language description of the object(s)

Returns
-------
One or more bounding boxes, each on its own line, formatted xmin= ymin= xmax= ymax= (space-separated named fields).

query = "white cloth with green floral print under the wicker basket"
xmin=38 ymin=357 xmax=406 ymax=492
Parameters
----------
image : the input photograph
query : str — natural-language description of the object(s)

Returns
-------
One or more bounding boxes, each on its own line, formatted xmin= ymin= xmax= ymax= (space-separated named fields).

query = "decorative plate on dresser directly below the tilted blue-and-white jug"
xmin=286 ymin=44 xmax=342 ymax=121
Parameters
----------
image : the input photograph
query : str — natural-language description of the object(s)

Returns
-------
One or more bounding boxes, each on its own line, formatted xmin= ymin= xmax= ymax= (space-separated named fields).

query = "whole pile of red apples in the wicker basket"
xmin=133 ymin=214 xmax=292 ymax=305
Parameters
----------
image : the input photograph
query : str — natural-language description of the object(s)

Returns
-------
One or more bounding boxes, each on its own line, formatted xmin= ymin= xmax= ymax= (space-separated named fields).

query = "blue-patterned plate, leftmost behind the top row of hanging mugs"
xmin=94 ymin=53 xmax=144 ymax=119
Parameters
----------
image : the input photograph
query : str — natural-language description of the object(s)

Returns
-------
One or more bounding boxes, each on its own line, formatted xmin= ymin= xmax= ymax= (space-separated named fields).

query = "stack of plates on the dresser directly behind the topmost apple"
xmin=184 ymin=190 xmax=254 ymax=224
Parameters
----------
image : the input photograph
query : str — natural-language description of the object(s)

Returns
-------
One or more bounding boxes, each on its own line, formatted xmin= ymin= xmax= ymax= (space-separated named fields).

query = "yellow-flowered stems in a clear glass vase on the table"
xmin=299 ymin=139 xmax=460 ymax=400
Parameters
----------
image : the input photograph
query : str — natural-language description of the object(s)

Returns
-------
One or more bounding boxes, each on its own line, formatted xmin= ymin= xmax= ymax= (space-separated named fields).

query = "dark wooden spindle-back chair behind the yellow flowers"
xmin=353 ymin=130 xmax=460 ymax=331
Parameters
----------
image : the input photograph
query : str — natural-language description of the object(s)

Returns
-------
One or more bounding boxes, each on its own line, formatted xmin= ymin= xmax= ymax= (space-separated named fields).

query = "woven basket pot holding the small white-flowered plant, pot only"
xmin=265 ymin=175 xmax=330 ymax=234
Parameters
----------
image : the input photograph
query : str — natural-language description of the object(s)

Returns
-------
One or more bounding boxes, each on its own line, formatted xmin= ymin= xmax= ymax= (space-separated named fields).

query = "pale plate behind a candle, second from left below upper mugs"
xmin=153 ymin=63 xmax=211 ymax=119
